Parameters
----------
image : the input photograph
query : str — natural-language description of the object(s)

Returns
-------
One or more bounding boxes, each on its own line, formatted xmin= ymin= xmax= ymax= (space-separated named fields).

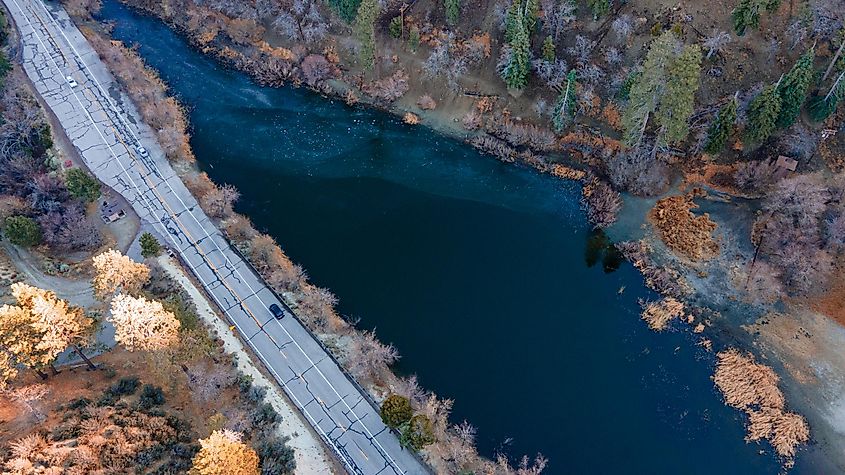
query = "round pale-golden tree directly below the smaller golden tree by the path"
xmin=109 ymin=294 xmax=180 ymax=351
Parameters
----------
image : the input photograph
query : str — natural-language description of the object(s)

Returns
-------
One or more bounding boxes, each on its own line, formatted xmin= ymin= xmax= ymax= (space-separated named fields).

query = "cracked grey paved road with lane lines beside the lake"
xmin=3 ymin=0 xmax=427 ymax=474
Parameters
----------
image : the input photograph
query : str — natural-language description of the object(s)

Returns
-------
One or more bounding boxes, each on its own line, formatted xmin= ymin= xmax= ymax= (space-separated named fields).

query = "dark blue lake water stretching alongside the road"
xmin=102 ymin=1 xmax=811 ymax=473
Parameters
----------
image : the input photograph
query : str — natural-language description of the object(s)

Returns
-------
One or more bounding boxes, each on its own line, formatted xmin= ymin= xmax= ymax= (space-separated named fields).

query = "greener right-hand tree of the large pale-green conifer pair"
xmin=655 ymin=45 xmax=701 ymax=143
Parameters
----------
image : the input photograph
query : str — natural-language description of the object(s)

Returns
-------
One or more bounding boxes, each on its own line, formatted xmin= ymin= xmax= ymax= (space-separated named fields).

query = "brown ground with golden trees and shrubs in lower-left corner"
xmin=0 ymin=250 xmax=295 ymax=475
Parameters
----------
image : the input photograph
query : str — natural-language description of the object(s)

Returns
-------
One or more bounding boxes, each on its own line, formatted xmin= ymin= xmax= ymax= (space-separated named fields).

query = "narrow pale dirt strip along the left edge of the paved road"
xmin=158 ymin=256 xmax=340 ymax=473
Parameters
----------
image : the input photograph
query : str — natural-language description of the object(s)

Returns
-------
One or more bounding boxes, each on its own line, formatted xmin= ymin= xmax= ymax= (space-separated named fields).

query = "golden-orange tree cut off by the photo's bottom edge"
xmin=188 ymin=429 xmax=258 ymax=475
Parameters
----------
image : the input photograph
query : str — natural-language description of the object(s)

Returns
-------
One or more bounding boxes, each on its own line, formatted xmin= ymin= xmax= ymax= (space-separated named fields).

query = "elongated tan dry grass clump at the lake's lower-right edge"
xmin=713 ymin=348 xmax=810 ymax=465
